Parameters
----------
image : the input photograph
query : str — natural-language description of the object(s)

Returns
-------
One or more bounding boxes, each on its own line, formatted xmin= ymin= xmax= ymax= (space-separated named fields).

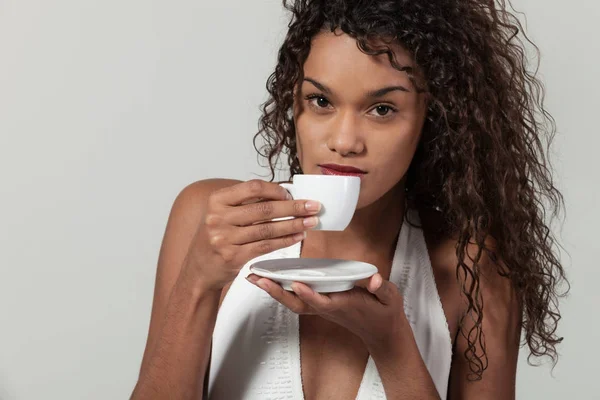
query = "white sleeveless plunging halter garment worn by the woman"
xmin=208 ymin=212 xmax=452 ymax=400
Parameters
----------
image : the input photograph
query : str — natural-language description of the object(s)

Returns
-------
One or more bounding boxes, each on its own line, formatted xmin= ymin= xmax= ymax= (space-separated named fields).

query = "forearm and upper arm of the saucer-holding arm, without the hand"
xmin=369 ymin=240 xmax=521 ymax=400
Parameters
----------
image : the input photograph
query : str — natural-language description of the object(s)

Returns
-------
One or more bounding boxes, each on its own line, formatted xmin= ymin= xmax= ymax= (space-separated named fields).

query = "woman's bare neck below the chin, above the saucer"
xmin=303 ymin=183 xmax=405 ymax=260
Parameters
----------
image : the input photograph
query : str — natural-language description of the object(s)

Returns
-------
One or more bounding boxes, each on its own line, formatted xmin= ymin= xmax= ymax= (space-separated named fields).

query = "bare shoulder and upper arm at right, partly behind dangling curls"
xmin=424 ymin=209 xmax=521 ymax=399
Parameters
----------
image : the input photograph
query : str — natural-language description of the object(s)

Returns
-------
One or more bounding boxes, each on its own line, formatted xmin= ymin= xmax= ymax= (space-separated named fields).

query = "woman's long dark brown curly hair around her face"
xmin=254 ymin=0 xmax=568 ymax=379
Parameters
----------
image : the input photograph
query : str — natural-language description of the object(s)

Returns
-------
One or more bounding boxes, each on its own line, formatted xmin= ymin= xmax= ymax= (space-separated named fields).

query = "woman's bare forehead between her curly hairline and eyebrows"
xmin=304 ymin=31 xmax=414 ymax=86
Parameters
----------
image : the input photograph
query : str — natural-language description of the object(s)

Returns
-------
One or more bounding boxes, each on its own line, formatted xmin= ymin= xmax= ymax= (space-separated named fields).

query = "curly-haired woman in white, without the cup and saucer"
xmin=133 ymin=0 xmax=564 ymax=399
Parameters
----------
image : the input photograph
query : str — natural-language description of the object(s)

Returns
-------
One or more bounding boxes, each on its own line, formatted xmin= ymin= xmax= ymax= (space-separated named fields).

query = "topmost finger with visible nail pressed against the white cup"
xmin=225 ymin=200 xmax=321 ymax=226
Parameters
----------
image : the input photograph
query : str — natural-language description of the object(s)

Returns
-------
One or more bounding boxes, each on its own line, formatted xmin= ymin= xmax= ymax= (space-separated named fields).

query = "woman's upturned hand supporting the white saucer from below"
xmin=246 ymin=273 xmax=408 ymax=347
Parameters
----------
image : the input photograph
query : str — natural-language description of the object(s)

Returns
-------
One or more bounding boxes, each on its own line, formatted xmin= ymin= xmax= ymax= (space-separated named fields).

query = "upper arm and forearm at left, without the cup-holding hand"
xmin=132 ymin=180 xmax=241 ymax=399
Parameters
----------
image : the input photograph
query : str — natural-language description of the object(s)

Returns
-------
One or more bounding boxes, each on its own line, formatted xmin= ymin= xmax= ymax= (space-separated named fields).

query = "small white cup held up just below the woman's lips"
xmin=280 ymin=174 xmax=360 ymax=231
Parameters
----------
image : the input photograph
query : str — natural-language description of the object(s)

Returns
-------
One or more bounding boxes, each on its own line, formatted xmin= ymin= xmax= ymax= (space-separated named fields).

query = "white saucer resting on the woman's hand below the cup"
xmin=250 ymin=258 xmax=377 ymax=293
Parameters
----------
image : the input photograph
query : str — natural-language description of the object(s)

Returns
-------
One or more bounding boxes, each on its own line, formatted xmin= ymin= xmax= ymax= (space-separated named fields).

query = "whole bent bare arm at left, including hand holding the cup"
xmin=132 ymin=180 xmax=318 ymax=399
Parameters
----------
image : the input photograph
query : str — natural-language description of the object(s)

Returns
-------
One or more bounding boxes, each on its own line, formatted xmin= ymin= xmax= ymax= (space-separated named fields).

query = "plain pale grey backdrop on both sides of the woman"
xmin=0 ymin=0 xmax=600 ymax=400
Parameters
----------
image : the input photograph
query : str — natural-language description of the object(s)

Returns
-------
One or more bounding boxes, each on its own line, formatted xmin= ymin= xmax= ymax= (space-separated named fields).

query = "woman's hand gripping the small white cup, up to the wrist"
xmin=183 ymin=179 xmax=321 ymax=290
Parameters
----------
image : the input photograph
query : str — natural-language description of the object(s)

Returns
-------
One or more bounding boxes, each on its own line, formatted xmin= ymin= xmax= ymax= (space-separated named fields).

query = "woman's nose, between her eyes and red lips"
xmin=327 ymin=112 xmax=365 ymax=156
